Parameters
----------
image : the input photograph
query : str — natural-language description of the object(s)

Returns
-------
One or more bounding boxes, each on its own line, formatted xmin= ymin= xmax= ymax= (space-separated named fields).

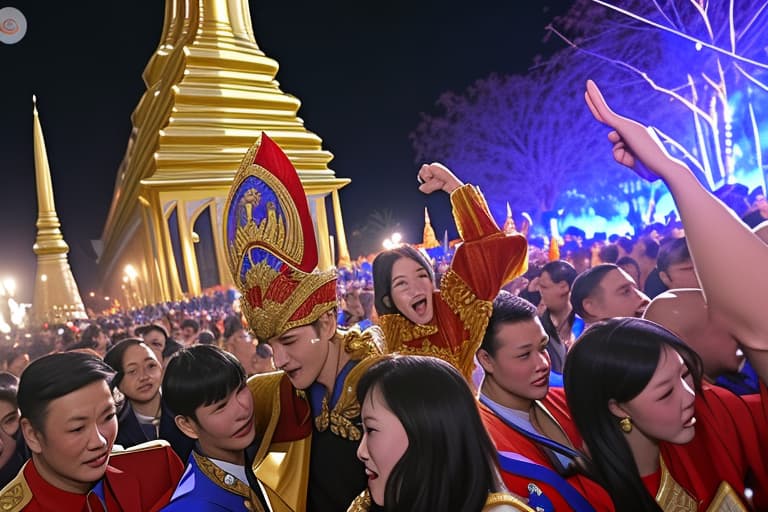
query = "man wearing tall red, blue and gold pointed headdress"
xmin=224 ymin=134 xmax=383 ymax=512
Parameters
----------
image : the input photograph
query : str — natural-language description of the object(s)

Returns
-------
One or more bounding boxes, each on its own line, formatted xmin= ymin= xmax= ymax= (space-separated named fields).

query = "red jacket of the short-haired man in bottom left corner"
xmin=0 ymin=442 xmax=184 ymax=512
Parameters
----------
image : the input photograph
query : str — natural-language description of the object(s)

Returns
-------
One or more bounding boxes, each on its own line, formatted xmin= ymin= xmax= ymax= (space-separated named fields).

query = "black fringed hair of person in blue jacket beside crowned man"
xmin=163 ymin=345 xmax=245 ymax=421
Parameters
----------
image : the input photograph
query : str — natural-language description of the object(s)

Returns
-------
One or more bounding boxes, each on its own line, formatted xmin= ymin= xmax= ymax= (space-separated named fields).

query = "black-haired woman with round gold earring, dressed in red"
xmin=563 ymin=318 xmax=768 ymax=512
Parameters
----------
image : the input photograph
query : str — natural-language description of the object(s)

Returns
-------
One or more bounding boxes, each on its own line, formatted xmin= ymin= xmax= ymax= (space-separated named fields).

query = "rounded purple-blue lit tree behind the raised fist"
xmin=410 ymin=64 xmax=631 ymax=224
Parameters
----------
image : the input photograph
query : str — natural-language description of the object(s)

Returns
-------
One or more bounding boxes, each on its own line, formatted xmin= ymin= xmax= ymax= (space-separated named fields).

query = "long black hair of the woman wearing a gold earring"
xmin=563 ymin=318 xmax=703 ymax=511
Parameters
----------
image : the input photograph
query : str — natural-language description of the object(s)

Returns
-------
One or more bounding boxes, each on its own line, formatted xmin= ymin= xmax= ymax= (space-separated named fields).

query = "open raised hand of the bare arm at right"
xmin=584 ymin=80 xmax=685 ymax=181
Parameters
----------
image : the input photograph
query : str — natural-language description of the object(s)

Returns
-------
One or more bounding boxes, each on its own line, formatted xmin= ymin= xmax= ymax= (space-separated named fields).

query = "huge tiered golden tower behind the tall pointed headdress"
xmin=95 ymin=0 xmax=356 ymax=307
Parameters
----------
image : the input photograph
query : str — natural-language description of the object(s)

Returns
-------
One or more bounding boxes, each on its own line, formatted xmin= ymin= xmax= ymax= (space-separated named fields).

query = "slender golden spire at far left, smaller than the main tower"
xmin=32 ymin=96 xmax=86 ymax=323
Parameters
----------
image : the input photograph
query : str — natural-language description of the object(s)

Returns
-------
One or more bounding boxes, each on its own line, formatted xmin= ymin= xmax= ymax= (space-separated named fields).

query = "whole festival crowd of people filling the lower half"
xmin=0 ymin=82 xmax=768 ymax=512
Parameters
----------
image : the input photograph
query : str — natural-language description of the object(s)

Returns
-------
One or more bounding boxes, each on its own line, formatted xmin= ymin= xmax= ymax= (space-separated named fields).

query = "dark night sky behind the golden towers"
xmin=0 ymin=0 xmax=570 ymax=300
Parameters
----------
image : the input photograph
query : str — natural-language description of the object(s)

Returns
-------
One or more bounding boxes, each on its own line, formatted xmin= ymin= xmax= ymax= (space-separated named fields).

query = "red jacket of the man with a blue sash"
xmin=479 ymin=388 xmax=615 ymax=512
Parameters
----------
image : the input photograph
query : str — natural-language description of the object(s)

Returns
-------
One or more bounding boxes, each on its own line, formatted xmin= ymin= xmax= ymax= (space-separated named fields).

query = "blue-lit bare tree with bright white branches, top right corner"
xmin=548 ymin=0 xmax=768 ymax=189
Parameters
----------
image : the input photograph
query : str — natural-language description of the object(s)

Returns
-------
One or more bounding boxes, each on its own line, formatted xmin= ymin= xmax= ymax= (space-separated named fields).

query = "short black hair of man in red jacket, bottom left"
xmin=18 ymin=352 xmax=114 ymax=431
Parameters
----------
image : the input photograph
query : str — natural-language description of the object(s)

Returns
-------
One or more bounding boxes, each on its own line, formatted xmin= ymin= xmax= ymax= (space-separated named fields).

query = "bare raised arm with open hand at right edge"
xmin=585 ymin=80 xmax=768 ymax=350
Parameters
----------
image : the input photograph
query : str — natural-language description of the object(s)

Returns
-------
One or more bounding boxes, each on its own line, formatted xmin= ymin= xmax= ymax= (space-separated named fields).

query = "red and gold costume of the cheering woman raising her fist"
xmin=379 ymin=185 xmax=528 ymax=382
